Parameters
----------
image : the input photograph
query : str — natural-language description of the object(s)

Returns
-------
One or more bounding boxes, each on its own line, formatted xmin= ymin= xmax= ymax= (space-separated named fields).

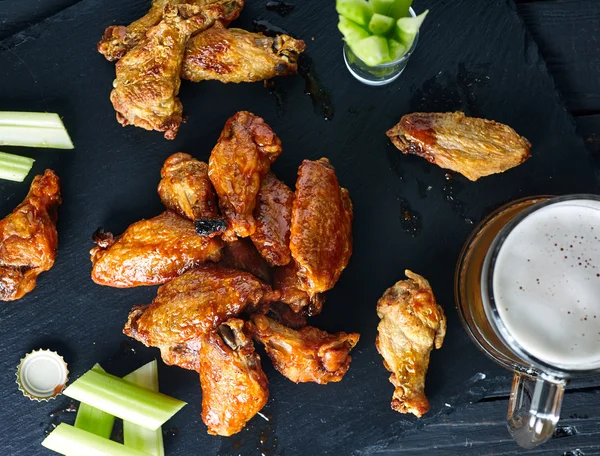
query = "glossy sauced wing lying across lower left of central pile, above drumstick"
xmin=123 ymin=265 xmax=279 ymax=370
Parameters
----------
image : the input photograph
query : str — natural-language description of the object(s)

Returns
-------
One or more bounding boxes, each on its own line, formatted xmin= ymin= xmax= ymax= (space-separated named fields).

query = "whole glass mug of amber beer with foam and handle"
xmin=455 ymin=195 xmax=600 ymax=448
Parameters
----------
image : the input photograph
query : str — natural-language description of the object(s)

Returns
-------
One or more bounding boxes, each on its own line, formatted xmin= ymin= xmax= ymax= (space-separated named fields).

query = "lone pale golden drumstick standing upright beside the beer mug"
xmin=376 ymin=270 xmax=446 ymax=417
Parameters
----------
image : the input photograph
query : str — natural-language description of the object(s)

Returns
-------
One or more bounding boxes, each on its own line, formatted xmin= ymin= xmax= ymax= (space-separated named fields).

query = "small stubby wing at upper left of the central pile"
xmin=158 ymin=152 xmax=219 ymax=220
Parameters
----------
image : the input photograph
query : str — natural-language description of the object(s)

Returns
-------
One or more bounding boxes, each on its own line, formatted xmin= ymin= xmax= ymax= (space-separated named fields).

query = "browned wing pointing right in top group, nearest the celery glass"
xmin=181 ymin=24 xmax=306 ymax=83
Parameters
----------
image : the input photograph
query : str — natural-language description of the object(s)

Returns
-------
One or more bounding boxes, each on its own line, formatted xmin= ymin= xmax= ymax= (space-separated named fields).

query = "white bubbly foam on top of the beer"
xmin=493 ymin=199 xmax=600 ymax=370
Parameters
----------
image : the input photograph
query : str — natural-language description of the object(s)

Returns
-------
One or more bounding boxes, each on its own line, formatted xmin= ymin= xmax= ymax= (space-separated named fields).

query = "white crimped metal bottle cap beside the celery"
xmin=17 ymin=350 xmax=69 ymax=401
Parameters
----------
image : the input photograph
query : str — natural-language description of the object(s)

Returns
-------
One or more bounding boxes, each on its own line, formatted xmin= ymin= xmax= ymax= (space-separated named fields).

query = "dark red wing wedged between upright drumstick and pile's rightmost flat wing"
xmin=250 ymin=172 xmax=294 ymax=266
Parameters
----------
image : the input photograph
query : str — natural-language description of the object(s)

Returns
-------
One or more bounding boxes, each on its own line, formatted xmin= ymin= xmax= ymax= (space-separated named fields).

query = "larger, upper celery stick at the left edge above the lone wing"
xmin=0 ymin=111 xmax=73 ymax=149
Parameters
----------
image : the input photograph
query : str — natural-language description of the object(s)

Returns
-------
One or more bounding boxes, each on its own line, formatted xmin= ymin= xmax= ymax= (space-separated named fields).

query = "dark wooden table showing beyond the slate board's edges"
xmin=0 ymin=0 xmax=600 ymax=456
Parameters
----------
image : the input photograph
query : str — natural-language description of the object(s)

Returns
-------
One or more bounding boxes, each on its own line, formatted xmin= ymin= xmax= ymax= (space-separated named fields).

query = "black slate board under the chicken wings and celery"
xmin=0 ymin=0 xmax=598 ymax=455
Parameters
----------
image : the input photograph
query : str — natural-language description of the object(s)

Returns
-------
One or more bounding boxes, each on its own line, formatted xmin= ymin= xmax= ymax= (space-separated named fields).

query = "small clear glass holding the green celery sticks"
xmin=343 ymin=8 xmax=419 ymax=86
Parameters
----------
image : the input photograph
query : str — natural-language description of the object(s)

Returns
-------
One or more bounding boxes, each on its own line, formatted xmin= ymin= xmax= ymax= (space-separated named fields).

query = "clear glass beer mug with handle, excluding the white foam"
xmin=454 ymin=195 xmax=600 ymax=448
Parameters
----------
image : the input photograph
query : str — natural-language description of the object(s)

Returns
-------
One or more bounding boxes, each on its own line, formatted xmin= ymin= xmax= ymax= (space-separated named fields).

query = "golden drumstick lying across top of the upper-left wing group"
xmin=110 ymin=0 xmax=242 ymax=139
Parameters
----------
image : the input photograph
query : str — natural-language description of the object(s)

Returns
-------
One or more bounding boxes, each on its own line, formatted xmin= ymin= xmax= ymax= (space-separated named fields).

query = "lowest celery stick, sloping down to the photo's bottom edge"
xmin=42 ymin=423 xmax=148 ymax=456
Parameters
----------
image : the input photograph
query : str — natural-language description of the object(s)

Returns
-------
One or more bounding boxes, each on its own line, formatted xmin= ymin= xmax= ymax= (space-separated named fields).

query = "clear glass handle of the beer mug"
xmin=506 ymin=372 xmax=567 ymax=449
